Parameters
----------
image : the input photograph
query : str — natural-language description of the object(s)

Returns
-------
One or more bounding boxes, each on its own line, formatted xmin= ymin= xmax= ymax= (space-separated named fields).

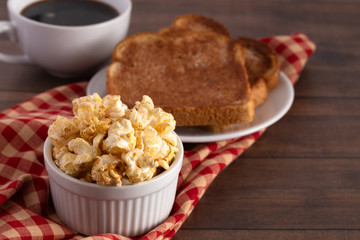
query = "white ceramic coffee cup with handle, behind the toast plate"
xmin=0 ymin=0 xmax=132 ymax=77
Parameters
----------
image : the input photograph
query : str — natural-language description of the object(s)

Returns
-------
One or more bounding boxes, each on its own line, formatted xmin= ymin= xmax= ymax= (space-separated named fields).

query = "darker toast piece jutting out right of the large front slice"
xmin=235 ymin=37 xmax=280 ymax=107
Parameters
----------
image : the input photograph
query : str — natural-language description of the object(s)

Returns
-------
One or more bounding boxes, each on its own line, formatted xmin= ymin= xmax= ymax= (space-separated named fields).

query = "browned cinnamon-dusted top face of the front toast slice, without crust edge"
xmin=108 ymin=33 xmax=249 ymax=107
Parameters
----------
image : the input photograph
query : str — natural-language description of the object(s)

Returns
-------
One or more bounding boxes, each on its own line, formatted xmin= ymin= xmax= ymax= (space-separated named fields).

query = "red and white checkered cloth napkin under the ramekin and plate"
xmin=0 ymin=33 xmax=315 ymax=239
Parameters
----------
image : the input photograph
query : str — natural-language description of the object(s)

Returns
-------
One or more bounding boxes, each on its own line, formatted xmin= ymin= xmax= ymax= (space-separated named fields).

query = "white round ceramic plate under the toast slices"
xmin=86 ymin=67 xmax=294 ymax=143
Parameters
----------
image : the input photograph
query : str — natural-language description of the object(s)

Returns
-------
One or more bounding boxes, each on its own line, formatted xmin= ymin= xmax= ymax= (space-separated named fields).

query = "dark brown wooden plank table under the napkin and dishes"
xmin=0 ymin=0 xmax=360 ymax=239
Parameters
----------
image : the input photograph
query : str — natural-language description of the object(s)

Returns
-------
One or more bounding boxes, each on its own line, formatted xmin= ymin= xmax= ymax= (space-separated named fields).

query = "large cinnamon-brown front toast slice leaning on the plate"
xmin=107 ymin=23 xmax=254 ymax=126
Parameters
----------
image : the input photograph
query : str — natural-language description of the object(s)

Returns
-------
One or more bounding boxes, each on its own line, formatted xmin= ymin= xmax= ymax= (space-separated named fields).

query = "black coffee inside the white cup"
xmin=21 ymin=0 xmax=120 ymax=26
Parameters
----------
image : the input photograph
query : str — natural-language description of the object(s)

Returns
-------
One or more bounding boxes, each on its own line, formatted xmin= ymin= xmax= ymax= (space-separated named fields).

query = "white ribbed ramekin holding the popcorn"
xmin=44 ymin=134 xmax=184 ymax=237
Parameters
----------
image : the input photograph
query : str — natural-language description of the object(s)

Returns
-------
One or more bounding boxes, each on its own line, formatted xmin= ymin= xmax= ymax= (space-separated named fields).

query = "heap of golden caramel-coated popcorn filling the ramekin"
xmin=48 ymin=93 xmax=178 ymax=186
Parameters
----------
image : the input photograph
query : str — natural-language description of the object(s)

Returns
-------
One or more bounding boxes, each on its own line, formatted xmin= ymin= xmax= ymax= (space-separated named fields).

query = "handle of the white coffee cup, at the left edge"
xmin=0 ymin=21 xmax=32 ymax=64
